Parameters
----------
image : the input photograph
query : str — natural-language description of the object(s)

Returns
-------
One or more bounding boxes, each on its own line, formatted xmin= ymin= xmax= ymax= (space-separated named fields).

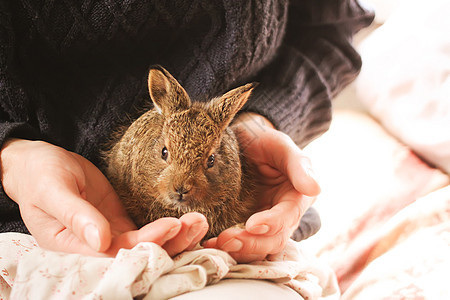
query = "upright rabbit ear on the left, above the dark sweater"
xmin=148 ymin=66 xmax=191 ymax=116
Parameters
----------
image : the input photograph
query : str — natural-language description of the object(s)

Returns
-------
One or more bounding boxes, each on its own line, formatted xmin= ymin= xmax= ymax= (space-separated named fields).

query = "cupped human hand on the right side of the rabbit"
xmin=203 ymin=113 xmax=320 ymax=262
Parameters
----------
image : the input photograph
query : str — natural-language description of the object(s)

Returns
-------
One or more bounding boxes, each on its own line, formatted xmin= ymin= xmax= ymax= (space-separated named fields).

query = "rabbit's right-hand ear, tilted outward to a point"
xmin=208 ymin=82 xmax=258 ymax=129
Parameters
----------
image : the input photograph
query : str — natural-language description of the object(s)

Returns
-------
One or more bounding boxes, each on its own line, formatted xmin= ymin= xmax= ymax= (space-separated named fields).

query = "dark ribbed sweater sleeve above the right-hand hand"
xmin=244 ymin=0 xmax=374 ymax=147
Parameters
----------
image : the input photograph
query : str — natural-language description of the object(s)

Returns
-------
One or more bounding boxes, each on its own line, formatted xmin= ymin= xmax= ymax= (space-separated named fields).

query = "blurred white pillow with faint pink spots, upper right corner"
xmin=356 ymin=0 xmax=450 ymax=173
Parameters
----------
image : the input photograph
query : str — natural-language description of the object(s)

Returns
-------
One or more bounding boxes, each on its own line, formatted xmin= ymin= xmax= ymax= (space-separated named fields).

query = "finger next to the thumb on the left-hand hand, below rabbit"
xmin=106 ymin=218 xmax=182 ymax=256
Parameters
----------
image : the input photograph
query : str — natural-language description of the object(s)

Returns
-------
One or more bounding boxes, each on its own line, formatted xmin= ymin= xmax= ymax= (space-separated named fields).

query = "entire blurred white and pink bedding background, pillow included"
xmin=301 ymin=0 xmax=450 ymax=299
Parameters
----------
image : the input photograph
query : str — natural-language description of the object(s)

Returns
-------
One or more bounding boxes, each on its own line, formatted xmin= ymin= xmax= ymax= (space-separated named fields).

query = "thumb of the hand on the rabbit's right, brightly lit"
xmin=262 ymin=132 xmax=320 ymax=196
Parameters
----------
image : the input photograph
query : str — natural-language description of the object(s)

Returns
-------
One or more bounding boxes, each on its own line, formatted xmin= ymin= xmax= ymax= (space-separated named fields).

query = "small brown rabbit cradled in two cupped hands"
xmin=104 ymin=66 xmax=255 ymax=238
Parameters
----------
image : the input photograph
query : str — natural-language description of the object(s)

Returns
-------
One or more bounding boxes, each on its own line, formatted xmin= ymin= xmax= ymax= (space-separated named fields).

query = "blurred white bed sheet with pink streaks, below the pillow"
xmin=305 ymin=111 xmax=450 ymax=299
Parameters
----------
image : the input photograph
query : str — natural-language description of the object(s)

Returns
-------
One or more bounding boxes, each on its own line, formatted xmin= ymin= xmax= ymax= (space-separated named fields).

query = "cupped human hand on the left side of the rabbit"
xmin=1 ymin=139 xmax=208 ymax=256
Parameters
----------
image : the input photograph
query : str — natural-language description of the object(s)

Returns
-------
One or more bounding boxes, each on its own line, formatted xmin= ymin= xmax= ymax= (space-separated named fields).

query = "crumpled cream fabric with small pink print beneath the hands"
xmin=0 ymin=233 xmax=339 ymax=299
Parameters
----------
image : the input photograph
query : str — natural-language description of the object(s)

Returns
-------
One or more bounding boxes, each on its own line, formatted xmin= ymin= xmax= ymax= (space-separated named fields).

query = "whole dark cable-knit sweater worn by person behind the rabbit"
xmin=0 ymin=0 xmax=373 ymax=232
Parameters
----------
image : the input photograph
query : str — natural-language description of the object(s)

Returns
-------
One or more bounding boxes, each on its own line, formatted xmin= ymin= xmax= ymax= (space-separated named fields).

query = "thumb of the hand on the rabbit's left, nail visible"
xmin=40 ymin=179 xmax=111 ymax=251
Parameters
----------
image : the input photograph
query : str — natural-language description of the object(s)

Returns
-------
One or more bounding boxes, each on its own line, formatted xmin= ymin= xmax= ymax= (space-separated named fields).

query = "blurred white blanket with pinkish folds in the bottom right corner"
xmin=342 ymin=186 xmax=450 ymax=300
